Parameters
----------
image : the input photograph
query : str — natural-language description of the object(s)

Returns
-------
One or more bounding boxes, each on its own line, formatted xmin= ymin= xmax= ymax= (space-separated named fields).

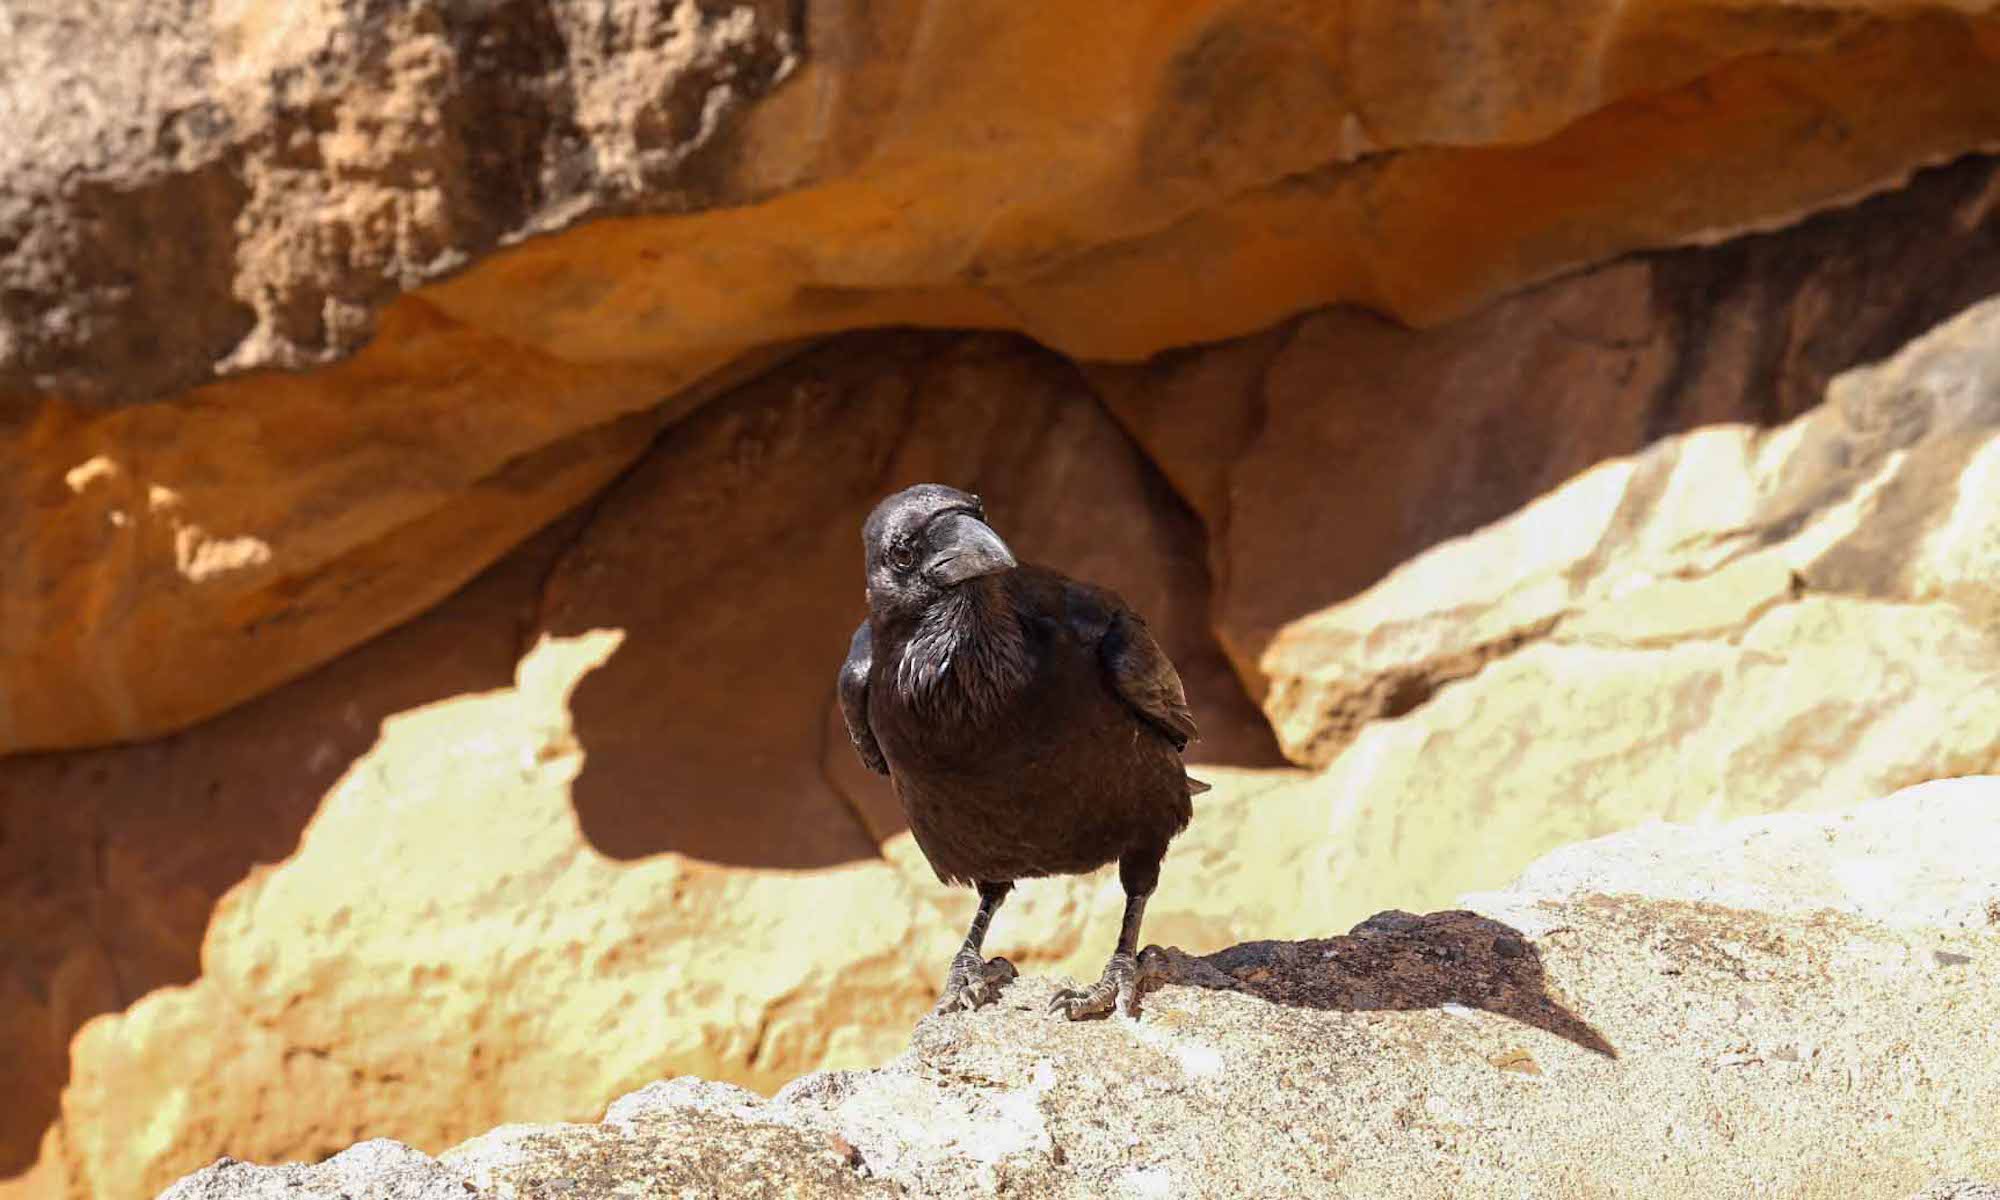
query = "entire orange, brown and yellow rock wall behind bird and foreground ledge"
xmin=0 ymin=0 xmax=2000 ymax=1200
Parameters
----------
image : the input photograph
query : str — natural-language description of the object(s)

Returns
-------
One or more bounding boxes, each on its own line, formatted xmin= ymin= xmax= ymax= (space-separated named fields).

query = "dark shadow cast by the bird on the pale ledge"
xmin=1140 ymin=910 xmax=1618 ymax=1058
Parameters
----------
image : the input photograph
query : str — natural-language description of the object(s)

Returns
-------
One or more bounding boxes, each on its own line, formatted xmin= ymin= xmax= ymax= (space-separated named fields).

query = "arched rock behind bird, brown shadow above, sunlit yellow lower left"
xmin=0 ymin=334 xmax=1276 ymax=1196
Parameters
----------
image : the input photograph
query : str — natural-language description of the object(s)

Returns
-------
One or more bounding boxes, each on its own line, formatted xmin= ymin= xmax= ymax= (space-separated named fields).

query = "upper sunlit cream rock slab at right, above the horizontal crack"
xmin=1264 ymin=284 xmax=2000 ymax=762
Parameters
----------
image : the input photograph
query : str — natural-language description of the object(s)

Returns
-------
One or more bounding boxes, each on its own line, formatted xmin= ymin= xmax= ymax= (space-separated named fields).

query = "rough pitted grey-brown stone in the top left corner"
xmin=0 ymin=0 xmax=802 ymax=400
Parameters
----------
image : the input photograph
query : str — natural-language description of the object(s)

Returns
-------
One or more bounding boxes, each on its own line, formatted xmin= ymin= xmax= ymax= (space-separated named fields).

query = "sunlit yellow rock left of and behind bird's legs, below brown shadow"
xmin=22 ymin=672 xmax=1288 ymax=1198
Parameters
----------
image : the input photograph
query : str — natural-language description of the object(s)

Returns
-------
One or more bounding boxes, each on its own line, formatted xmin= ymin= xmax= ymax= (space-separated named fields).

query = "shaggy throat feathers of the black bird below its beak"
xmin=896 ymin=576 xmax=1030 ymax=720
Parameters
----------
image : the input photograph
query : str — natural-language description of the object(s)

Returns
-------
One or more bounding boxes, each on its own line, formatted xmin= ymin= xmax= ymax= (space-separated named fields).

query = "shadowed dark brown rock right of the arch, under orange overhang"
xmin=1090 ymin=156 xmax=2000 ymax=736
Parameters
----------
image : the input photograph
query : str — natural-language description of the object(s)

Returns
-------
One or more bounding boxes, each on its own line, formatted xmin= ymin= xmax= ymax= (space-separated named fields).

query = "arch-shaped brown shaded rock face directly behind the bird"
xmin=540 ymin=330 xmax=1282 ymax=868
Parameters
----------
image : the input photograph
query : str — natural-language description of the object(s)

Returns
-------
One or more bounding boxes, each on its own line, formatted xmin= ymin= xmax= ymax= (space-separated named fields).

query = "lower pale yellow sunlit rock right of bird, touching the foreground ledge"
xmin=1264 ymin=596 xmax=2000 ymax=932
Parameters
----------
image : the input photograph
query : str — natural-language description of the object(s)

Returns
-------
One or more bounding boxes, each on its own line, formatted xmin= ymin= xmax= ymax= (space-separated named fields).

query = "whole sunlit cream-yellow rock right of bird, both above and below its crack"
xmin=1128 ymin=286 xmax=2000 ymax=932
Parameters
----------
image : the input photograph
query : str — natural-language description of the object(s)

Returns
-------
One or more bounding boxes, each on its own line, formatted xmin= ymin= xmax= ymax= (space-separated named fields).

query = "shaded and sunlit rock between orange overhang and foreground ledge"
xmin=11 ymin=162 xmax=2000 ymax=1200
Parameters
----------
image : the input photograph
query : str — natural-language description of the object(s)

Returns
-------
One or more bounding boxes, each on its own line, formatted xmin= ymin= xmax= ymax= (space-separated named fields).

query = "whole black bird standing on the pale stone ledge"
xmin=838 ymin=484 xmax=1208 ymax=1020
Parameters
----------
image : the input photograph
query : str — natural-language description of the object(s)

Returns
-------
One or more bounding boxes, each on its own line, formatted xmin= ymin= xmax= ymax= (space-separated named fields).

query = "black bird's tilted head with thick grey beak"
xmin=862 ymin=484 xmax=1014 ymax=616
